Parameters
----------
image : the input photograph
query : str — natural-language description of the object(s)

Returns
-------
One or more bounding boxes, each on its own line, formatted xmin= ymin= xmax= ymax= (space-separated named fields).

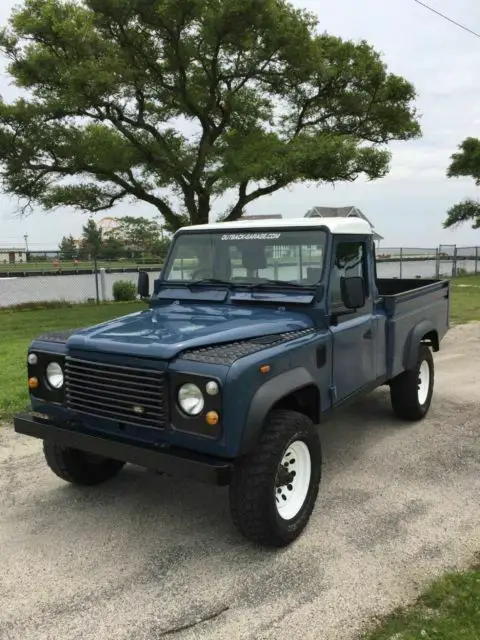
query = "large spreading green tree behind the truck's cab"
xmin=0 ymin=0 xmax=420 ymax=230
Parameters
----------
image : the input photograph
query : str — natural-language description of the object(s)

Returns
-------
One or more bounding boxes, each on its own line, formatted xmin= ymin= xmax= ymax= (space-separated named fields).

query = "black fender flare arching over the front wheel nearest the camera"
xmin=239 ymin=367 xmax=315 ymax=455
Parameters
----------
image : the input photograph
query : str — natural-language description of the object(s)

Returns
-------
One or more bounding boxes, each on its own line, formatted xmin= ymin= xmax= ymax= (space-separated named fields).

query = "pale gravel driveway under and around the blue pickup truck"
xmin=0 ymin=324 xmax=480 ymax=640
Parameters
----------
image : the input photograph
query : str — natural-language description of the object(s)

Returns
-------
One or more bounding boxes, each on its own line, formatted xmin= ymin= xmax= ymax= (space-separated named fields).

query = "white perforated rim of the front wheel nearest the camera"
xmin=275 ymin=440 xmax=312 ymax=520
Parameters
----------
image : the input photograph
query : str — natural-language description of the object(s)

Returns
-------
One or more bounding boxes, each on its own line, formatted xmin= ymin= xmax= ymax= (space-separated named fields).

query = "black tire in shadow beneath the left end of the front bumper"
xmin=43 ymin=440 xmax=125 ymax=486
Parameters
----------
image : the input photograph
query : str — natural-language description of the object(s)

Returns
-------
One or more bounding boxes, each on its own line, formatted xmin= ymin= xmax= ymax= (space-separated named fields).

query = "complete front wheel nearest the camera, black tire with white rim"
xmin=230 ymin=410 xmax=322 ymax=547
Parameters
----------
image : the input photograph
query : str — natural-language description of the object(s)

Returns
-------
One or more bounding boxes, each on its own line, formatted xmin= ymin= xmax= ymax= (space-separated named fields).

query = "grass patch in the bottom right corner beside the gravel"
xmin=364 ymin=566 xmax=480 ymax=640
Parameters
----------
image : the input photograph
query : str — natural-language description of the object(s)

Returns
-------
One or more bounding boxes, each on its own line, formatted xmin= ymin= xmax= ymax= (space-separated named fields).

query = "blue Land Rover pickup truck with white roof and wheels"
xmin=14 ymin=218 xmax=449 ymax=547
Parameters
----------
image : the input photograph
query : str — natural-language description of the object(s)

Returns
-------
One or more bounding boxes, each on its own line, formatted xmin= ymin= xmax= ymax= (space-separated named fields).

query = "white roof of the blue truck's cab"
xmin=181 ymin=216 xmax=372 ymax=236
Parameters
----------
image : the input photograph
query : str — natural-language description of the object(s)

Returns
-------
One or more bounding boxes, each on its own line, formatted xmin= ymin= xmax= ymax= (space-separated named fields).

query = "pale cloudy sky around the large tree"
xmin=0 ymin=0 xmax=480 ymax=250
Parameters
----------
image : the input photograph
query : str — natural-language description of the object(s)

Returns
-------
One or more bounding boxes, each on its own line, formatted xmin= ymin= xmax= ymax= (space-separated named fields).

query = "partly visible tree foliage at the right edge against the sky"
xmin=443 ymin=138 xmax=480 ymax=229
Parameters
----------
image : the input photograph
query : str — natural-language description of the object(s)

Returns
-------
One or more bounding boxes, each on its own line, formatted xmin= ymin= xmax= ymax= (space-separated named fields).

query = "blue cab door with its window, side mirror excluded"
xmin=328 ymin=235 xmax=377 ymax=403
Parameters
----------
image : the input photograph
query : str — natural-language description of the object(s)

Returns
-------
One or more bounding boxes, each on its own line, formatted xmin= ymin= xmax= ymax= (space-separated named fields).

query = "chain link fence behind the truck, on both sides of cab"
xmin=0 ymin=245 xmax=480 ymax=307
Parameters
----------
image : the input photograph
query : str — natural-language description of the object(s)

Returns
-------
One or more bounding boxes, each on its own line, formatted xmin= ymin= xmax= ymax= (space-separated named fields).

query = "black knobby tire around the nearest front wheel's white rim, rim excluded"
xmin=230 ymin=410 xmax=322 ymax=547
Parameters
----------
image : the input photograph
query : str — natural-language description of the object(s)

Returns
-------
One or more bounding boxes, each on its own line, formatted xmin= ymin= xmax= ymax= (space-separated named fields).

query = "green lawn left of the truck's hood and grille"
xmin=0 ymin=302 xmax=145 ymax=420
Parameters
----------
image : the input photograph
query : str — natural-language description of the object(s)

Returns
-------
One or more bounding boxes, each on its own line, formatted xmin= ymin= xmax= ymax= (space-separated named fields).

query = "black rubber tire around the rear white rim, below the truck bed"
xmin=390 ymin=344 xmax=435 ymax=422
